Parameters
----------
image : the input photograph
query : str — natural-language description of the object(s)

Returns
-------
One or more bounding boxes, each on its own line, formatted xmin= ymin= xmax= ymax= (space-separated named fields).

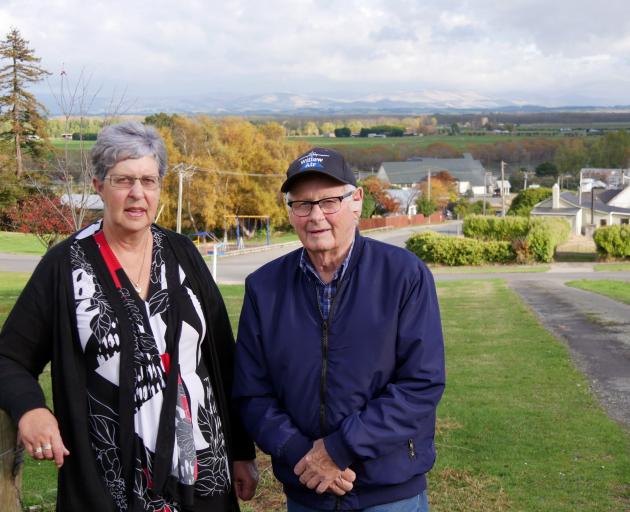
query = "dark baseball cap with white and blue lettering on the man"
xmin=280 ymin=148 xmax=357 ymax=192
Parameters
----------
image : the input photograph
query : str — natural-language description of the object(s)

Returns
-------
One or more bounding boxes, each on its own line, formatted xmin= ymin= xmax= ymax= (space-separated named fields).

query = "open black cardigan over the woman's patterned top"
xmin=0 ymin=228 xmax=255 ymax=512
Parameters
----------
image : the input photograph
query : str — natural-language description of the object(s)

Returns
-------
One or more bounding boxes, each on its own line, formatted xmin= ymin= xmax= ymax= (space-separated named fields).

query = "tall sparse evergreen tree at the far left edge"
xmin=0 ymin=28 xmax=50 ymax=176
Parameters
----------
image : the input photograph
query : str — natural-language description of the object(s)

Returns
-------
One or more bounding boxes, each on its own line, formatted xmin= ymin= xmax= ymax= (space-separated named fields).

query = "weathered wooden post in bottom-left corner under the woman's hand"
xmin=0 ymin=409 xmax=22 ymax=512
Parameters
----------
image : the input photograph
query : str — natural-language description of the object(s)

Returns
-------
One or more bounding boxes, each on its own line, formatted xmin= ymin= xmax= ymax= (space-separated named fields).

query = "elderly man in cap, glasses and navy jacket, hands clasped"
xmin=234 ymin=148 xmax=445 ymax=512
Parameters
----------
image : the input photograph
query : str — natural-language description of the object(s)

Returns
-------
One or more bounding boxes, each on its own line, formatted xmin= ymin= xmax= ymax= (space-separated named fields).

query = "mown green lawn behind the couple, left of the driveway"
xmin=0 ymin=273 xmax=630 ymax=512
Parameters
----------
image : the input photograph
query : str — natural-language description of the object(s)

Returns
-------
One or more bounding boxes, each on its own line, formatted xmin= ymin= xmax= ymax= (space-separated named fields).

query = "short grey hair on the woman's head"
xmin=90 ymin=121 xmax=168 ymax=181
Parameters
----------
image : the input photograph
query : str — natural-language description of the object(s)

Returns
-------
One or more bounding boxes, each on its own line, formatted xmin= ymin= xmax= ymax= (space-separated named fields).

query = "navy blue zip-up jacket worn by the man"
xmin=234 ymin=234 xmax=445 ymax=510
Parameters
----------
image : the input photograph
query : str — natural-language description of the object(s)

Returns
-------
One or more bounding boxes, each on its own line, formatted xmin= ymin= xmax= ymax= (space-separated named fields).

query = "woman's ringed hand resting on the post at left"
xmin=18 ymin=407 xmax=70 ymax=468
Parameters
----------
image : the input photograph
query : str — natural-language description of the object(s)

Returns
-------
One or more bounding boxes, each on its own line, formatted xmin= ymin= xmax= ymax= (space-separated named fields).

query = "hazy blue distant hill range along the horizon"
xmin=38 ymin=91 xmax=630 ymax=116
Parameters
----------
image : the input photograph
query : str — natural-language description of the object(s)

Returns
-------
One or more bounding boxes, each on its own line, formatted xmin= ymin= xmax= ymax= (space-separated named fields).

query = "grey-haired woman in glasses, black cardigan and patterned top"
xmin=0 ymin=123 xmax=257 ymax=512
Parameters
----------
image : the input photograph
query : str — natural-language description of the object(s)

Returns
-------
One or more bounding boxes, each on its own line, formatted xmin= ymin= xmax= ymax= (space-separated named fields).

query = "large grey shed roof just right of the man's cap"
xmin=378 ymin=153 xmax=486 ymax=186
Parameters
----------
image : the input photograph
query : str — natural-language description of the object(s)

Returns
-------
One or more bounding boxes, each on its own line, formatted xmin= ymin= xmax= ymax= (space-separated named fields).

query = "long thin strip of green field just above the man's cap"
xmin=287 ymin=133 xmax=562 ymax=151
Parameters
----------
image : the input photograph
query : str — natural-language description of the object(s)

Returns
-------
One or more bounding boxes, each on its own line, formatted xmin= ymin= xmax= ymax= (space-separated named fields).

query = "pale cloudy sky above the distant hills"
xmin=0 ymin=0 xmax=630 ymax=106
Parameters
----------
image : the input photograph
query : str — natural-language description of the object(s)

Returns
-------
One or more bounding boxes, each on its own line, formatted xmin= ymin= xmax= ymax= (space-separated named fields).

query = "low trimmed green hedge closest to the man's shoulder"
xmin=406 ymin=231 xmax=516 ymax=266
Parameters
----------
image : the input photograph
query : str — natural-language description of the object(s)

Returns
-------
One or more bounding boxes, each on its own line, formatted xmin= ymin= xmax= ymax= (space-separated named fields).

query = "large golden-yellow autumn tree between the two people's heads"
xmin=159 ymin=116 xmax=307 ymax=232
